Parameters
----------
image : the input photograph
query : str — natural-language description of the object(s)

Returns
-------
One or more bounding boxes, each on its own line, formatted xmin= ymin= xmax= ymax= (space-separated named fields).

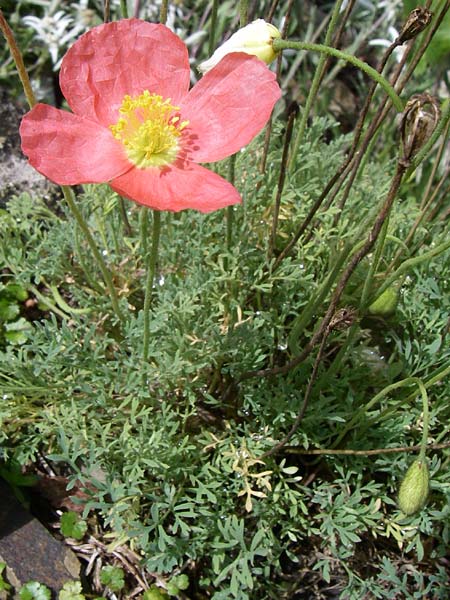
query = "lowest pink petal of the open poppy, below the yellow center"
xmin=110 ymin=163 xmax=241 ymax=213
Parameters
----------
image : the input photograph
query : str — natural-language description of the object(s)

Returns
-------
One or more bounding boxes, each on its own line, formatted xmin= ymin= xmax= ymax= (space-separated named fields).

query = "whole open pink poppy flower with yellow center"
xmin=20 ymin=19 xmax=281 ymax=212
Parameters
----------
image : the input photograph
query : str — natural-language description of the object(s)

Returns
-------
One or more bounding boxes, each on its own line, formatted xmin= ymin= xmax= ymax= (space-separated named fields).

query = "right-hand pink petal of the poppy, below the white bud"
xmin=180 ymin=52 xmax=281 ymax=162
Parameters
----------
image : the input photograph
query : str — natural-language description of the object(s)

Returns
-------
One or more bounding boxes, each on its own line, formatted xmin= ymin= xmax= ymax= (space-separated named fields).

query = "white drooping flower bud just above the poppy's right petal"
xmin=198 ymin=19 xmax=281 ymax=73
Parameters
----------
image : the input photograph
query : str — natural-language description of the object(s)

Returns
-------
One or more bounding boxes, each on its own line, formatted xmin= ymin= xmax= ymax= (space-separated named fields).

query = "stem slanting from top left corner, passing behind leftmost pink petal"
xmin=0 ymin=10 xmax=123 ymax=321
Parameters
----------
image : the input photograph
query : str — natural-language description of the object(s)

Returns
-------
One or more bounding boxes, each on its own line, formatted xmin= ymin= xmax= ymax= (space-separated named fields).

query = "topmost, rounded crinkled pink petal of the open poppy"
xmin=60 ymin=19 xmax=190 ymax=126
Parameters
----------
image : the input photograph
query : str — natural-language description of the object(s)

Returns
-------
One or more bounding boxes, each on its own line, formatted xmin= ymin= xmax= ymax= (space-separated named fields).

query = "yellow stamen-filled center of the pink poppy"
xmin=109 ymin=90 xmax=189 ymax=169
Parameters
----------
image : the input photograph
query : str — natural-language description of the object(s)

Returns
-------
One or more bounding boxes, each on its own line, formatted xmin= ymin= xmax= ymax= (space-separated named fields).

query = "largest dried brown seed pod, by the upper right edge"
xmin=400 ymin=94 xmax=441 ymax=160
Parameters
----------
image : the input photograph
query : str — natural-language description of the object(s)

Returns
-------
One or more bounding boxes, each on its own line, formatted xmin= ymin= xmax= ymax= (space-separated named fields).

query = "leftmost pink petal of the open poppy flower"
xmin=20 ymin=104 xmax=131 ymax=185
